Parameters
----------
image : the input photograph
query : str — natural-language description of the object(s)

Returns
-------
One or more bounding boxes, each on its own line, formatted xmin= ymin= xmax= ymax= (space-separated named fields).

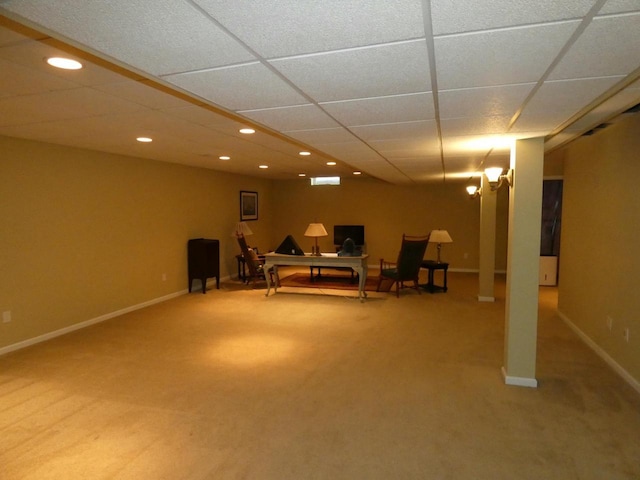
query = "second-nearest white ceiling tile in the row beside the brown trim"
xmin=164 ymin=63 xmax=309 ymax=110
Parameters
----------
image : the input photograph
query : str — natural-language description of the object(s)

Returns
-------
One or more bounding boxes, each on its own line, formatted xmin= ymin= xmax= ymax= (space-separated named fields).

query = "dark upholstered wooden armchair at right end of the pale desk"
xmin=376 ymin=235 xmax=429 ymax=297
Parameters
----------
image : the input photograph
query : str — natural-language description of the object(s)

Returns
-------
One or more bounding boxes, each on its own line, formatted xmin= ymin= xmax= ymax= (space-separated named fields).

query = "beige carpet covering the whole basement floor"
xmin=0 ymin=273 xmax=640 ymax=480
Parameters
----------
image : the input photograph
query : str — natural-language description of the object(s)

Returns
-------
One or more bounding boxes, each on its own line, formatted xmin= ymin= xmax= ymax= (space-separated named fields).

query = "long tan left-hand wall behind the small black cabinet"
xmin=0 ymin=137 xmax=273 ymax=348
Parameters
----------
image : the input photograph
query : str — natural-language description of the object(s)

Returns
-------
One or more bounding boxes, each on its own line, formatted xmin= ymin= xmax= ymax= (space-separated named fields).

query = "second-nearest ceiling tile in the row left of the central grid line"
xmin=272 ymin=40 xmax=431 ymax=102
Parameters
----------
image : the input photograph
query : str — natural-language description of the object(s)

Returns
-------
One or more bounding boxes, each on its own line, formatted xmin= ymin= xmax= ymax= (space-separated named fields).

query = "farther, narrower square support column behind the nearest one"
xmin=478 ymin=175 xmax=498 ymax=302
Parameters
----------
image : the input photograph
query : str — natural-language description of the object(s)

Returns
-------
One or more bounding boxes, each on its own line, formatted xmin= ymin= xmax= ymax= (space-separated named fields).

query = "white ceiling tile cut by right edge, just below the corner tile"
xmin=549 ymin=13 xmax=640 ymax=80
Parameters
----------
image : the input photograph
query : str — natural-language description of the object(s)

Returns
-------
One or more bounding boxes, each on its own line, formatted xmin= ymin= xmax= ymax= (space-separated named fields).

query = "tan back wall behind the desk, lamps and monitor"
xmin=269 ymin=178 xmax=508 ymax=270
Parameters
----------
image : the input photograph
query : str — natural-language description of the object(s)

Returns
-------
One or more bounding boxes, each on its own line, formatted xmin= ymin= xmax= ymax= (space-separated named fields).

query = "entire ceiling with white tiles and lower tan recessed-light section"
xmin=0 ymin=0 xmax=640 ymax=184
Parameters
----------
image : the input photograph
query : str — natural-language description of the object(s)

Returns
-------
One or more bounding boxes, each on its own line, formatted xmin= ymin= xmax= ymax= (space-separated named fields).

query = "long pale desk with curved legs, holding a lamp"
xmin=264 ymin=253 xmax=369 ymax=302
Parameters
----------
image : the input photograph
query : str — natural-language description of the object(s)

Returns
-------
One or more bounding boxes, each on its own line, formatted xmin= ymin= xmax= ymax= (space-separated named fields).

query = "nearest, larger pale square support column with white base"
xmin=503 ymin=138 xmax=544 ymax=387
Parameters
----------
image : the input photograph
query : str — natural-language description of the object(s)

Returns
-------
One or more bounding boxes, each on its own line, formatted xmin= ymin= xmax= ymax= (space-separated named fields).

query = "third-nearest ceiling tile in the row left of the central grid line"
xmin=322 ymin=92 xmax=434 ymax=126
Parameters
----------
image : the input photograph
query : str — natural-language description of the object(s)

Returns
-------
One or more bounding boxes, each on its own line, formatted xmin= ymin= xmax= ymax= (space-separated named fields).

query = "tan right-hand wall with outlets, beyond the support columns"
xmin=554 ymin=115 xmax=640 ymax=381
